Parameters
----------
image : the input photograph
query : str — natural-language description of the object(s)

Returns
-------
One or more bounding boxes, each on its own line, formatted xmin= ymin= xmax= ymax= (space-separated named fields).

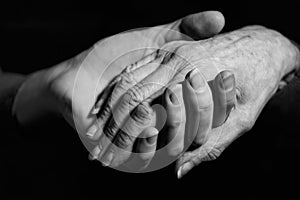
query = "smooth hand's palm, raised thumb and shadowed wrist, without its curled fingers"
xmin=14 ymin=11 xmax=224 ymax=150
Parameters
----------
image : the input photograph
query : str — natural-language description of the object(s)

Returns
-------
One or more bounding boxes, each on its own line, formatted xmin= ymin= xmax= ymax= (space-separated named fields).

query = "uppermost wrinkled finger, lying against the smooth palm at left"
xmin=87 ymin=52 xmax=160 ymax=140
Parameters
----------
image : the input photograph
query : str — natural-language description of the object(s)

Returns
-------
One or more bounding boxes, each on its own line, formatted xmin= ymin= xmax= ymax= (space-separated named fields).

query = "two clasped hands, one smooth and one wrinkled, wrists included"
xmin=14 ymin=11 xmax=299 ymax=177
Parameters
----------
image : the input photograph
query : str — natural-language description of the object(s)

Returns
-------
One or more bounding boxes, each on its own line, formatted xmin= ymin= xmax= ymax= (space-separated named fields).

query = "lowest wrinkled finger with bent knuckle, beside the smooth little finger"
xmin=98 ymin=102 xmax=152 ymax=167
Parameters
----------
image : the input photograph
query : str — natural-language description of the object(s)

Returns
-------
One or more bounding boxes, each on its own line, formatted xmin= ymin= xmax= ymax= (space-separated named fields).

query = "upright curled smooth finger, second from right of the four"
xmin=183 ymin=69 xmax=214 ymax=145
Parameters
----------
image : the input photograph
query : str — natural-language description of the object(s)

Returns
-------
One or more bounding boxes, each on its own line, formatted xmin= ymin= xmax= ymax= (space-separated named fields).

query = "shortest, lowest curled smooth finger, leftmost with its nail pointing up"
xmin=125 ymin=127 xmax=158 ymax=172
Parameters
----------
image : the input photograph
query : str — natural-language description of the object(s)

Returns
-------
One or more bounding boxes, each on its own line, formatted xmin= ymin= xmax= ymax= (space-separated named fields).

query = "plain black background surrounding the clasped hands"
xmin=0 ymin=0 xmax=300 ymax=199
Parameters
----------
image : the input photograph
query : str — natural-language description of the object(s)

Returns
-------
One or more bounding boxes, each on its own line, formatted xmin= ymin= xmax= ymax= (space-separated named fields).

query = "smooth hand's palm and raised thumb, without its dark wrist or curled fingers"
xmin=46 ymin=11 xmax=224 ymax=150
